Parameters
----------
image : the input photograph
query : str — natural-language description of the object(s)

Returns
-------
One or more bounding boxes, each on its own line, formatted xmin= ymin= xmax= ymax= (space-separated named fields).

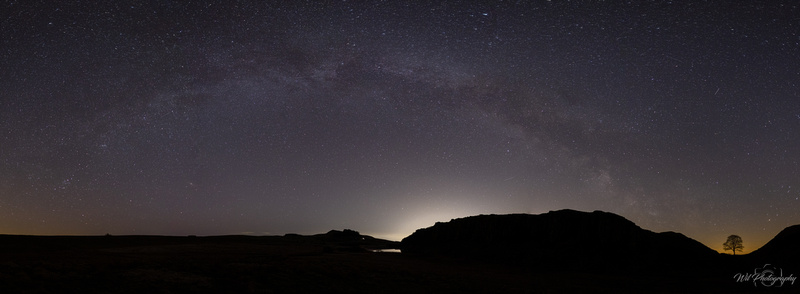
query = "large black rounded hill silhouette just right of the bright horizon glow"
xmin=401 ymin=210 xmax=718 ymax=270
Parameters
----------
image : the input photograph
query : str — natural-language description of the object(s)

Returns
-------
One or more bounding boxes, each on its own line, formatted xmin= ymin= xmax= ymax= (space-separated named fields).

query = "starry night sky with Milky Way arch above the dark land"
xmin=0 ymin=1 xmax=800 ymax=252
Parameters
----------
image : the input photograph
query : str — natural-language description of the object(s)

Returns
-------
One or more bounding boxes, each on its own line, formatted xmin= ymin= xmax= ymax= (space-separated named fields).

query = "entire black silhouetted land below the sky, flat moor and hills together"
xmin=6 ymin=210 xmax=800 ymax=293
